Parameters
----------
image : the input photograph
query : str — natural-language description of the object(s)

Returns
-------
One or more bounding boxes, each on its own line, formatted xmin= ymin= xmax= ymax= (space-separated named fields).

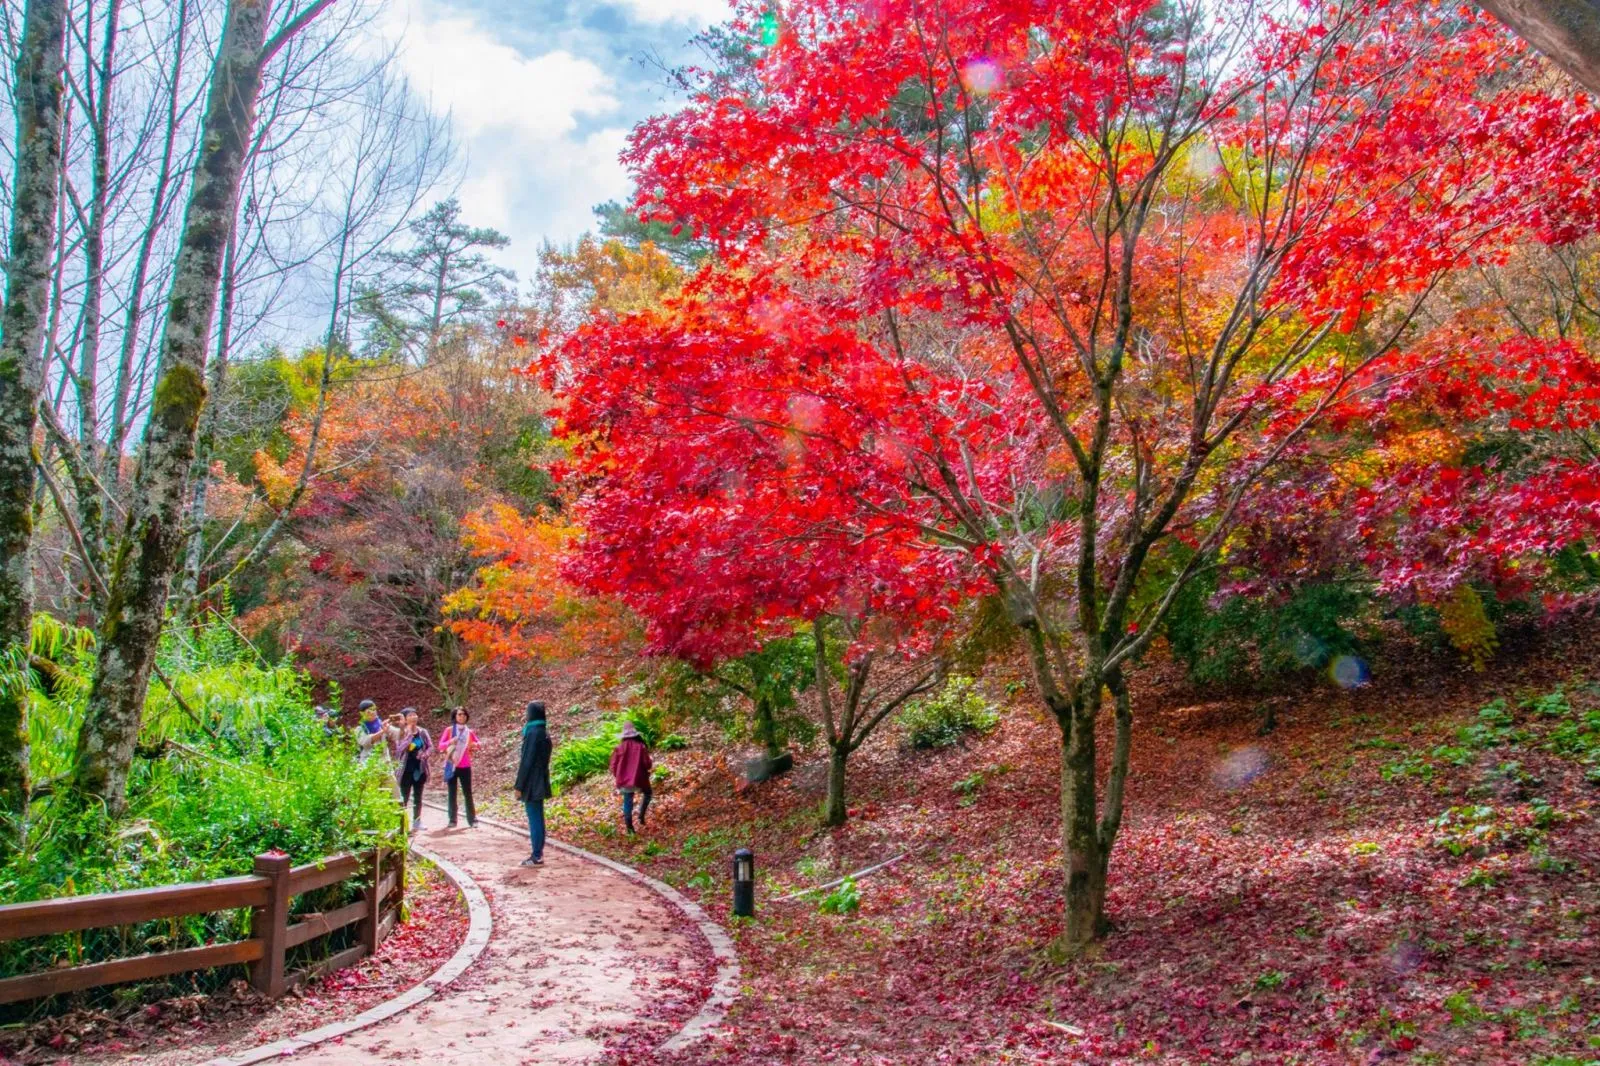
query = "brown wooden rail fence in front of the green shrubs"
xmin=0 ymin=848 xmax=405 ymax=1004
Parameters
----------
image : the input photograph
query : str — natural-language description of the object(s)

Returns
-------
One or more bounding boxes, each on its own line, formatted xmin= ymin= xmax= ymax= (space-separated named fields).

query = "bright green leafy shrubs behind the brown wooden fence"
xmin=0 ymin=616 xmax=398 ymax=992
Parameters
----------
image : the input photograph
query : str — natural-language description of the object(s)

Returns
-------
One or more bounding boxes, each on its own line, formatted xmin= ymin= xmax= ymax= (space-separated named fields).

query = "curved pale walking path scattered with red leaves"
xmin=290 ymin=812 xmax=720 ymax=1066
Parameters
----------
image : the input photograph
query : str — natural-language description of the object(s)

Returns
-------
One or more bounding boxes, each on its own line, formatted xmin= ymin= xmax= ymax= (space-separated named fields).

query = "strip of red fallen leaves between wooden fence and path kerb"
xmin=0 ymin=863 xmax=467 ymax=1066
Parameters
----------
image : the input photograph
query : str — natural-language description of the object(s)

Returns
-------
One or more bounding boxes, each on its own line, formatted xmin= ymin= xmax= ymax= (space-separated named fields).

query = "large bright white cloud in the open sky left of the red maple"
xmin=382 ymin=0 xmax=636 ymax=279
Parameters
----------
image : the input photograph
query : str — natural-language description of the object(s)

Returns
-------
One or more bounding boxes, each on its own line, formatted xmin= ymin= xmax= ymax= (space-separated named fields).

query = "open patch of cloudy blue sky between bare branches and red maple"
xmin=381 ymin=0 xmax=728 ymax=279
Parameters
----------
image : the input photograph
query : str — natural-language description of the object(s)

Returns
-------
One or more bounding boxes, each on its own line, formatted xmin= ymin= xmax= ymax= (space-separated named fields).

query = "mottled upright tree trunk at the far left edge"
xmin=0 ymin=0 xmax=67 ymax=850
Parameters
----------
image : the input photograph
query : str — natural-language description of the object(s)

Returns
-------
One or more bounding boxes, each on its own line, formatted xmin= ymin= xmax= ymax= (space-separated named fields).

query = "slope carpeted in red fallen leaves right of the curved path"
xmin=540 ymin=634 xmax=1600 ymax=1066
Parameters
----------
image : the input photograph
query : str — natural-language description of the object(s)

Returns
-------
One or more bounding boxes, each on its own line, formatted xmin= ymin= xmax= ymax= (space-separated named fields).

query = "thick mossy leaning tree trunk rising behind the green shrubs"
xmin=74 ymin=0 xmax=270 ymax=812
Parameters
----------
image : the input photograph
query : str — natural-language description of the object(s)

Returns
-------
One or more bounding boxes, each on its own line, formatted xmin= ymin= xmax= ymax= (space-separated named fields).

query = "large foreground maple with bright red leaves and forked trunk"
xmin=546 ymin=0 xmax=1600 ymax=946
